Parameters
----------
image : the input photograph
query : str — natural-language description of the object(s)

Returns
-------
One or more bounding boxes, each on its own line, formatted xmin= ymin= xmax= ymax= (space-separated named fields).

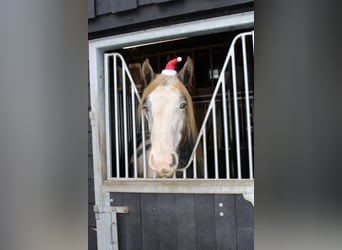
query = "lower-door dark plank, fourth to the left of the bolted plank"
xmin=140 ymin=194 xmax=159 ymax=250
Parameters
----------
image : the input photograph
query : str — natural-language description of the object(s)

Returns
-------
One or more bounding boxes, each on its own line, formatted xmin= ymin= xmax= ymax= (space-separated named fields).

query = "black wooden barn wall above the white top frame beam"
xmin=88 ymin=0 xmax=254 ymax=39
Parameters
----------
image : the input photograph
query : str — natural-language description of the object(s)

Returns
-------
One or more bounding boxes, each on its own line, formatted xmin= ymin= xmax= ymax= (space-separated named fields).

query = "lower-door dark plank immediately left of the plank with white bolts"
xmin=194 ymin=194 xmax=216 ymax=250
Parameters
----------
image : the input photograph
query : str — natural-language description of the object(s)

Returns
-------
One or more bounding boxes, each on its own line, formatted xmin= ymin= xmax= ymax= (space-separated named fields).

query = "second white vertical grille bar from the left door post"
xmin=113 ymin=56 xmax=120 ymax=178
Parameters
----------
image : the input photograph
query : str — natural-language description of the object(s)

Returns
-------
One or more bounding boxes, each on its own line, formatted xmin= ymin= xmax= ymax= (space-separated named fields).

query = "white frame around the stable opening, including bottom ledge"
xmin=89 ymin=11 xmax=254 ymax=204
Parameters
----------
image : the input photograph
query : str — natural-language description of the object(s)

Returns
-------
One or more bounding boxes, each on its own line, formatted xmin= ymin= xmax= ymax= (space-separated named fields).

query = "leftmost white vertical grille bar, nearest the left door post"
xmin=104 ymin=54 xmax=113 ymax=178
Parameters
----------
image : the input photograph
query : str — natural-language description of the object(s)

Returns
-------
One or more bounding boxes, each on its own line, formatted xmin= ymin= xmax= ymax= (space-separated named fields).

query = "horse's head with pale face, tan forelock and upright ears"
xmin=139 ymin=57 xmax=197 ymax=177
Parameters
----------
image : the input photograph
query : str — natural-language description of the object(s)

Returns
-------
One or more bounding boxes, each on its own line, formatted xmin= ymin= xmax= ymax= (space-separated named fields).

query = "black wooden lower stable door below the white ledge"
xmin=111 ymin=193 xmax=254 ymax=250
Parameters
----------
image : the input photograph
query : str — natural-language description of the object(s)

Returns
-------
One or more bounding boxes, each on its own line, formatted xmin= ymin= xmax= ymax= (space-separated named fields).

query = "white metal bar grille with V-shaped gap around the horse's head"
xmin=103 ymin=33 xmax=254 ymax=179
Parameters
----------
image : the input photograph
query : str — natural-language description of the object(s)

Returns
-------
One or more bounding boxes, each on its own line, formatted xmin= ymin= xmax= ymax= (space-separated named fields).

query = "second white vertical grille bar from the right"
xmin=232 ymin=43 xmax=241 ymax=179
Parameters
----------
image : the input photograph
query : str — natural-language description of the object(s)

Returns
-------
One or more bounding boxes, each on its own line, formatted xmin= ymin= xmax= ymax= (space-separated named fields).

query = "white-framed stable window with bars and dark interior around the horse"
xmin=90 ymin=14 xmax=254 ymax=193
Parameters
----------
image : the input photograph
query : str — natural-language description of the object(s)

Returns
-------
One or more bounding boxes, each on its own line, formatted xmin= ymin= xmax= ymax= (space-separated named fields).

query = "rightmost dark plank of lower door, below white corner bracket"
xmin=235 ymin=194 xmax=254 ymax=250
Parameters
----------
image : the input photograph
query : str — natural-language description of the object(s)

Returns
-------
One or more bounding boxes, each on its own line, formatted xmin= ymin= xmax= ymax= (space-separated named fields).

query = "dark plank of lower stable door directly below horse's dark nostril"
xmin=158 ymin=194 xmax=177 ymax=249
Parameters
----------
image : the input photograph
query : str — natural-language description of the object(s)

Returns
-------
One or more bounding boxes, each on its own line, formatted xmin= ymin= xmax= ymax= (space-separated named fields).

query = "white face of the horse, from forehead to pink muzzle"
xmin=144 ymin=77 xmax=187 ymax=177
